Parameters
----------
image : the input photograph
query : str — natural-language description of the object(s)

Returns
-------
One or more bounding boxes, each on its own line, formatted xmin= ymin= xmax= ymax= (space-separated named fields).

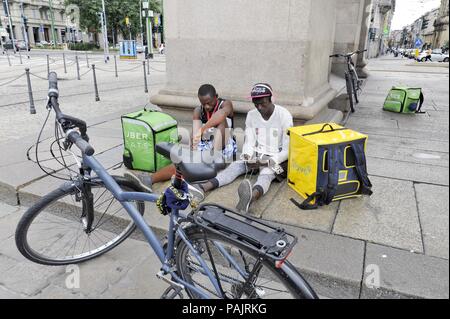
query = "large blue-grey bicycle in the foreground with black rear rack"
xmin=15 ymin=72 xmax=317 ymax=299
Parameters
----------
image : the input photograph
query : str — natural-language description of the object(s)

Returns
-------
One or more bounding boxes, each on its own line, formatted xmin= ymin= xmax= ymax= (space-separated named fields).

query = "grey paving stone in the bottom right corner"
xmin=361 ymin=243 xmax=449 ymax=299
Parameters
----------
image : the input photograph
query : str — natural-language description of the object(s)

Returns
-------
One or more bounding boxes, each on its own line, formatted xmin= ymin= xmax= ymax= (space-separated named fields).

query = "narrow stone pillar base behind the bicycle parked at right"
xmin=331 ymin=0 xmax=366 ymax=77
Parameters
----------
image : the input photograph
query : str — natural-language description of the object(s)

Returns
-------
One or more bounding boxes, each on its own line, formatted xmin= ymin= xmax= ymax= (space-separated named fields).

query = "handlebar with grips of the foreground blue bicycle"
xmin=48 ymin=72 xmax=95 ymax=156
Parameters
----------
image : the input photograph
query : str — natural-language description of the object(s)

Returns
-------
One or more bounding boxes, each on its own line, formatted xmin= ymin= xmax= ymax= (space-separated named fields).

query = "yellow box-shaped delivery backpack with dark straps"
xmin=288 ymin=123 xmax=372 ymax=209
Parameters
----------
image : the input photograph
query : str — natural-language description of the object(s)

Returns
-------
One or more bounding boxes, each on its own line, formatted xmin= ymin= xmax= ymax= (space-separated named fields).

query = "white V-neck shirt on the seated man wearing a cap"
xmin=242 ymin=105 xmax=294 ymax=164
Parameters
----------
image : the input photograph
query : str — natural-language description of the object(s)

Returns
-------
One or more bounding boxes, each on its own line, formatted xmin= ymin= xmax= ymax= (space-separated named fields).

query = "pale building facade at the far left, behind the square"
xmin=0 ymin=0 xmax=81 ymax=45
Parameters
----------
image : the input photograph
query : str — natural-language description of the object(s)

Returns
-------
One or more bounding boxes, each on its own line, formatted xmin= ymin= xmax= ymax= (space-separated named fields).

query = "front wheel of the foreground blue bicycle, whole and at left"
xmin=15 ymin=178 xmax=145 ymax=266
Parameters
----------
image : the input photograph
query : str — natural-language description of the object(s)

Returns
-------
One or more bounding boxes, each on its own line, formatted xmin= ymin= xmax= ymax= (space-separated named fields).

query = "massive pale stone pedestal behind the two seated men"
xmin=151 ymin=0 xmax=336 ymax=121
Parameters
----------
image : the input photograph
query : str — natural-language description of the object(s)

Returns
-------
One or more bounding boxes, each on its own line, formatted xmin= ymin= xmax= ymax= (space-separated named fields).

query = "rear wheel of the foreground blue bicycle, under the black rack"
xmin=176 ymin=231 xmax=317 ymax=299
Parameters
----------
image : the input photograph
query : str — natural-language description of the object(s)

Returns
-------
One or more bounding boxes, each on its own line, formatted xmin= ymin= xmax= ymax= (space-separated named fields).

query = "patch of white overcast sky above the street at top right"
xmin=392 ymin=0 xmax=441 ymax=30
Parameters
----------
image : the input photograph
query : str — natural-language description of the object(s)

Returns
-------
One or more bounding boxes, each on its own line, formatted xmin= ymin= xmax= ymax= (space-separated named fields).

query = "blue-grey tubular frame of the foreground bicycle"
xmin=83 ymin=155 xmax=236 ymax=299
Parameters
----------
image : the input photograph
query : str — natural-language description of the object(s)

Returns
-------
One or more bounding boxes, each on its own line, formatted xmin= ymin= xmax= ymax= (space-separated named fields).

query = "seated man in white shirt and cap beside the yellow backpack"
xmin=194 ymin=83 xmax=294 ymax=213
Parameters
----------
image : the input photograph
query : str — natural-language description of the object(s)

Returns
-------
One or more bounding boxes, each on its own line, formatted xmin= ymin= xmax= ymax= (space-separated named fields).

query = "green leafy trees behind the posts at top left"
xmin=65 ymin=0 xmax=161 ymax=40
